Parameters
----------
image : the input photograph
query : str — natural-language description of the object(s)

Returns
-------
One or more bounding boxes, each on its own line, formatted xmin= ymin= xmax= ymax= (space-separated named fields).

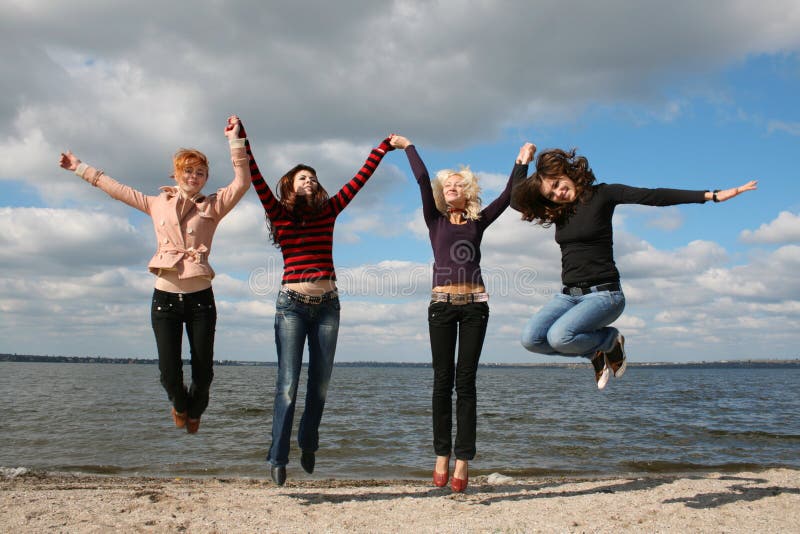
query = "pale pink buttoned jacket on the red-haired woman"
xmin=83 ymin=147 xmax=250 ymax=280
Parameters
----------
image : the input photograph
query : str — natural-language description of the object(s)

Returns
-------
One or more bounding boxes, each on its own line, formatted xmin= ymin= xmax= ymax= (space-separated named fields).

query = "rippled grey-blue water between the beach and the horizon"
xmin=0 ymin=362 xmax=800 ymax=479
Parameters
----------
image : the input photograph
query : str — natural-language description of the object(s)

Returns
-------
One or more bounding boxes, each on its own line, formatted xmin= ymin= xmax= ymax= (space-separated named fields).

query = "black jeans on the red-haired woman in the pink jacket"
xmin=150 ymin=287 xmax=217 ymax=419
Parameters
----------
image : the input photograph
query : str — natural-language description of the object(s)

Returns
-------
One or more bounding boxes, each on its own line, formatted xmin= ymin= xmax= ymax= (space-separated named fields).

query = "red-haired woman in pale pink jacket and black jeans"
xmin=59 ymin=115 xmax=250 ymax=434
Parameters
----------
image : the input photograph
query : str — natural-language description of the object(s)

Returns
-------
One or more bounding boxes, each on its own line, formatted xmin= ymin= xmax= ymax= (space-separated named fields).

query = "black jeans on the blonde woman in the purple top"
xmin=428 ymin=302 xmax=489 ymax=460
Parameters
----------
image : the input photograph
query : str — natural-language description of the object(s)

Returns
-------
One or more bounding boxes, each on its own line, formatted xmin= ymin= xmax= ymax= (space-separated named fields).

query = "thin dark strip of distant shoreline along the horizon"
xmin=0 ymin=354 xmax=800 ymax=369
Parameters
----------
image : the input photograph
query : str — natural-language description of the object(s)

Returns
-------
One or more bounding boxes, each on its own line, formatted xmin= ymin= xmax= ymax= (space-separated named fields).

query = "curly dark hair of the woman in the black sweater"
xmin=511 ymin=148 xmax=595 ymax=228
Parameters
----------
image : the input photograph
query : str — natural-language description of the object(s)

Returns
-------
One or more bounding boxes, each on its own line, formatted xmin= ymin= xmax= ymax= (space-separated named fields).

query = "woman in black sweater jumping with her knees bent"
xmin=511 ymin=149 xmax=757 ymax=389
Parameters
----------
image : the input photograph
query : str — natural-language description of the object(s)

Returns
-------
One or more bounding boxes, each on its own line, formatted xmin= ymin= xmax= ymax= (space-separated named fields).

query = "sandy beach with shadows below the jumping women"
xmin=0 ymin=469 xmax=800 ymax=533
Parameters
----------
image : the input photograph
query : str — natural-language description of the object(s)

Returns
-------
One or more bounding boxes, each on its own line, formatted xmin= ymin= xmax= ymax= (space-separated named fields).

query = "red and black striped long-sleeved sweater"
xmin=240 ymin=129 xmax=394 ymax=284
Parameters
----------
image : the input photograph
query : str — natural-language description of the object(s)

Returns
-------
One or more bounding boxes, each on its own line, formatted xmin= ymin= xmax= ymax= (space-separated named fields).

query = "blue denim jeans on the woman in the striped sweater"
xmin=267 ymin=293 xmax=341 ymax=466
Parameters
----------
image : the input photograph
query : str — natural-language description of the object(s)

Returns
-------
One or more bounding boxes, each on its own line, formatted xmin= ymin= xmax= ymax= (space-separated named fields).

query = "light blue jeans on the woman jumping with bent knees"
xmin=521 ymin=291 xmax=625 ymax=359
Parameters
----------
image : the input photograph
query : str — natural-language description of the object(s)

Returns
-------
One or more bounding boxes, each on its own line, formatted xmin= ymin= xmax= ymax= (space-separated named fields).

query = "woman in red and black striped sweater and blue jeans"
xmin=241 ymin=124 xmax=393 ymax=485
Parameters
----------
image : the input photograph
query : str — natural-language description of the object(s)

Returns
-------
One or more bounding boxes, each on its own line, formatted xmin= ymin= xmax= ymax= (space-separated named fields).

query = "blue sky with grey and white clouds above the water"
xmin=0 ymin=0 xmax=800 ymax=362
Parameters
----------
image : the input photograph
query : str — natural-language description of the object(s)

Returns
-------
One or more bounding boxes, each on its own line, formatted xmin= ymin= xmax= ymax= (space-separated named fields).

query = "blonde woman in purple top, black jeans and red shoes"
xmin=390 ymin=136 xmax=536 ymax=492
